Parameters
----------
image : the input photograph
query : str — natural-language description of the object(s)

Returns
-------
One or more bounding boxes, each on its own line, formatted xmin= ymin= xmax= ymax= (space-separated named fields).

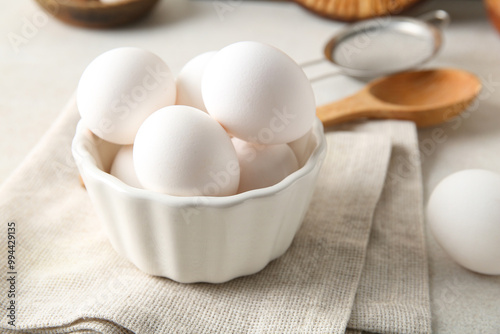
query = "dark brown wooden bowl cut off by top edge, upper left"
xmin=36 ymin=0 xmax=158 ymax=28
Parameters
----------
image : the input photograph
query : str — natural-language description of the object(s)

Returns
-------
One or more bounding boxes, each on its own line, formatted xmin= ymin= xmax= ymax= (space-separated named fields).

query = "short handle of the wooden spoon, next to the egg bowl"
xmin=316 ymin=95 xmax=373 ymax=127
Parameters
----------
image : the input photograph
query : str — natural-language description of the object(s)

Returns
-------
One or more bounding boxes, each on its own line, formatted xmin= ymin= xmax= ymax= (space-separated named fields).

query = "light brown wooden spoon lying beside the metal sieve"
xmin=316 ymin=69 xmax=481 ymax=127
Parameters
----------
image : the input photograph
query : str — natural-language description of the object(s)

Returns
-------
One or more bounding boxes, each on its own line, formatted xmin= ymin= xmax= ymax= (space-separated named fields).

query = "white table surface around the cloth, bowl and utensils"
xmin=0 ymin=0 xmax=500 ymax=334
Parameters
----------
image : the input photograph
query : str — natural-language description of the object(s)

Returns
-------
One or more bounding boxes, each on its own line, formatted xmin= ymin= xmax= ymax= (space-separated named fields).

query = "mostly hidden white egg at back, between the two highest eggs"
xmin=176 ymin=51 xmax=217 ymax=112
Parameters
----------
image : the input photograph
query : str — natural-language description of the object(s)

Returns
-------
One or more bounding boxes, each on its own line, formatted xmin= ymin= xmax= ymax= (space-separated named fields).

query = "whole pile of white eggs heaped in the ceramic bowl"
xmin=77 ymin=41 xmax=316 ymax=196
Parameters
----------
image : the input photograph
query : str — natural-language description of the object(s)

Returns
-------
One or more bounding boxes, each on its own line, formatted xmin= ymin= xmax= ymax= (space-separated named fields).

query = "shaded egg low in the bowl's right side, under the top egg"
xmin=232 ymin=138 xmax=299 ymax=193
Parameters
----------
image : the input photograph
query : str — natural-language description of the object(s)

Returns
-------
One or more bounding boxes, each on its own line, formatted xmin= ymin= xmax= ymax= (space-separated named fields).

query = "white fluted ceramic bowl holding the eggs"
xmin=72 ymin=119 xmax=326 ymax=283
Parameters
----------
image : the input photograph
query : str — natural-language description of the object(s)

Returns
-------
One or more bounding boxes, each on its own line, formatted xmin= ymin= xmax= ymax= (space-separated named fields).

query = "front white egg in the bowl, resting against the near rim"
xmin=133 ymin=106 xmax=240 ymax=196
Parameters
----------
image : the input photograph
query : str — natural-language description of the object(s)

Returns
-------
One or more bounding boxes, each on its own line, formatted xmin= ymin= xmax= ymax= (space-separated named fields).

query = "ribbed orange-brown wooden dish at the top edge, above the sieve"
xmin=294 ymin=0 xmax=420 ymax=22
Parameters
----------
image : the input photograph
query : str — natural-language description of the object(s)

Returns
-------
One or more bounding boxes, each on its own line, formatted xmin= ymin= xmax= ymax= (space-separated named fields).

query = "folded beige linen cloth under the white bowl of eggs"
xmin=0 ymin=100 xmax=431 ymax=333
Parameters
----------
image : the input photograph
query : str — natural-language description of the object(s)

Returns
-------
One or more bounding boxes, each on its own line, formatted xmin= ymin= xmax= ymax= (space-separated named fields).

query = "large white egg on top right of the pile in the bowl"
xmin=201 ymin=42 xmax=316 ymax=144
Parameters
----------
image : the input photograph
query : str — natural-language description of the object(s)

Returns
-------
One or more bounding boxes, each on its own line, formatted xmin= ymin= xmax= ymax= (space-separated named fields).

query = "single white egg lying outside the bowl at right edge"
xmin=426 ymin=169 xmax=500 ymax=275
